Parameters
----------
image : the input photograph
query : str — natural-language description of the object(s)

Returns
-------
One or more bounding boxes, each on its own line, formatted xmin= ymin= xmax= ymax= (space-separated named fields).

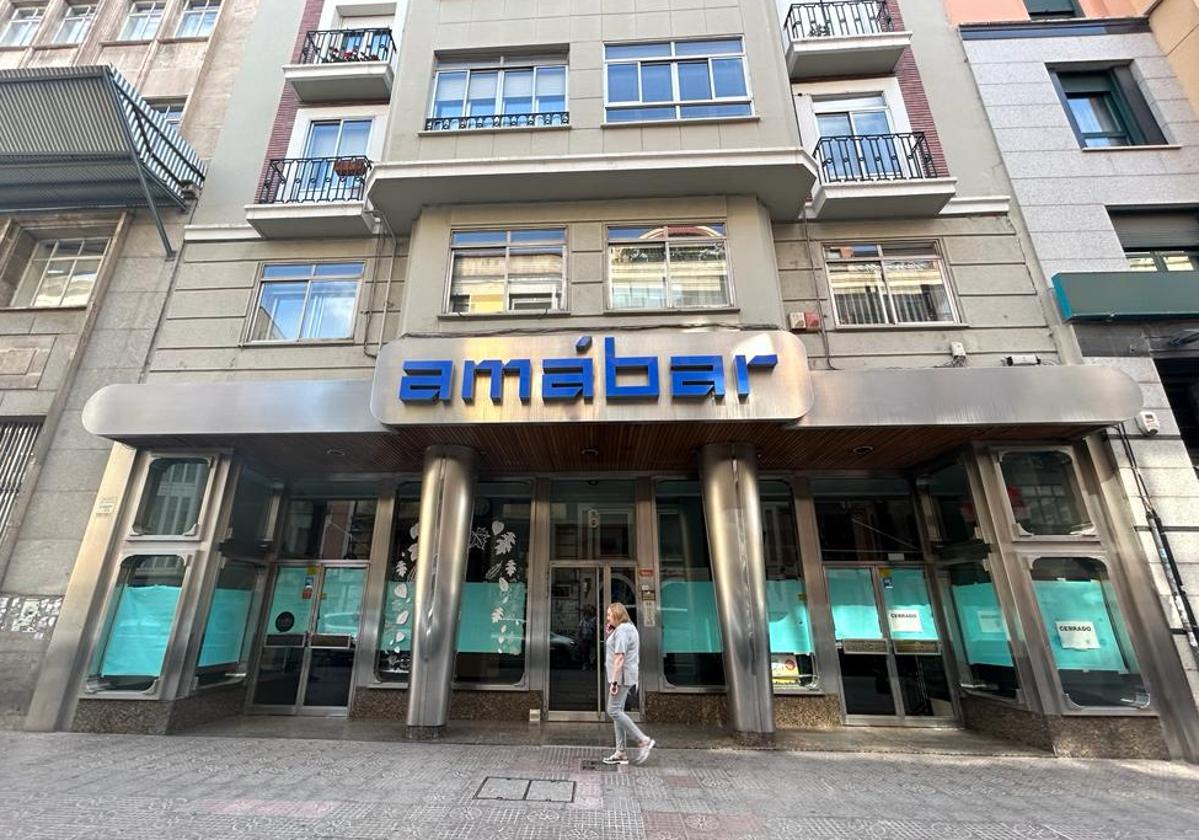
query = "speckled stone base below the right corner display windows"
xmin=962 ymin=695 xmax=1169 ymax=759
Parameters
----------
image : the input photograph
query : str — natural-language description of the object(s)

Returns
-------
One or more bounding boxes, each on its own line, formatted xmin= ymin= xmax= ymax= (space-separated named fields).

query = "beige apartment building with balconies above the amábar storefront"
xmin=9 ymin=0 xmax=1197 ymax=756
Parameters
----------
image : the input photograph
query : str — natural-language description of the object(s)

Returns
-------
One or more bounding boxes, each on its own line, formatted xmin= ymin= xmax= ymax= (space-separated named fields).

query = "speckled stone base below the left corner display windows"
xmin=71 ymin=684 xmax=246 ymax=735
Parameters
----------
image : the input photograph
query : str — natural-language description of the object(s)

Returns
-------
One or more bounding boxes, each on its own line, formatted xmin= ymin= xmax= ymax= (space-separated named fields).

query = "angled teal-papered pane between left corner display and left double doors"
xmin=195 ymin=560 xmax=263 ymax=687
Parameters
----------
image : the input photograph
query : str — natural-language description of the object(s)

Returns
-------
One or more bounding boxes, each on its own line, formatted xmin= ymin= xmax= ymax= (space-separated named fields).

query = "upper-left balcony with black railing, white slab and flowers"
xmin=283 ymin=29 xmax=396 ymax=103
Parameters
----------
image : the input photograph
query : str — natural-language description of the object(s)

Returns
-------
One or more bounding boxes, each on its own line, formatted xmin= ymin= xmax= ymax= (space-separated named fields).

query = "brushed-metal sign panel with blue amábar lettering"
xmin=370 ymin=330 xmax=812 ymax=425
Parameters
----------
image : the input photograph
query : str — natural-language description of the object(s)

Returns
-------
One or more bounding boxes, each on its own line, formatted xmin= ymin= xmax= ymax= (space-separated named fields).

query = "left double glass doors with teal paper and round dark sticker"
xmin=251 ymin=563 xmax=367 ymax=714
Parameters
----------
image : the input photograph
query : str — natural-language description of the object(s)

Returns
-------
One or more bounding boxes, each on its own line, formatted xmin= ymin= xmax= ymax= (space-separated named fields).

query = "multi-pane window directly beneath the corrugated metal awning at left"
xmin=8 ymin=236 xmax=109 ymax=308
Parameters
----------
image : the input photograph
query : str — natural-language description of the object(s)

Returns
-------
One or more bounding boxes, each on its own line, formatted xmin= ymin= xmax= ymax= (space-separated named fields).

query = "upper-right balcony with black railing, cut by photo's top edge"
xmin=783 ymin=0 xmax=911 ymax=80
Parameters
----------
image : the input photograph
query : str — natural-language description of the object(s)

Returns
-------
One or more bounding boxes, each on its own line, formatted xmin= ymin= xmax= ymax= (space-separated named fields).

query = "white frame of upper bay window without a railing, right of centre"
xmin=602 ymin=35 xmax=757 ymax=126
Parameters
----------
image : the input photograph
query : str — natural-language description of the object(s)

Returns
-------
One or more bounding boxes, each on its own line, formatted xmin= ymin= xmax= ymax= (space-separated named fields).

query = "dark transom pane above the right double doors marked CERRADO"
xmin=812 ymin=478 xmax=923 ymax=562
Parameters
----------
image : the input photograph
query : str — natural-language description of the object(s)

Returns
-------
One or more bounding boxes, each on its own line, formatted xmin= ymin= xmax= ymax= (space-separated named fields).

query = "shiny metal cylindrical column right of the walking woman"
xmin=699 ymin=443 xmax=775 ymax=741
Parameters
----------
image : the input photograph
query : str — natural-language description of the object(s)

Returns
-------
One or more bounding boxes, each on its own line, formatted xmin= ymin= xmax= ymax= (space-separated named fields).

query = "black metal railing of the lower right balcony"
xmin=815 ymin=132 xmax=940 ymax=183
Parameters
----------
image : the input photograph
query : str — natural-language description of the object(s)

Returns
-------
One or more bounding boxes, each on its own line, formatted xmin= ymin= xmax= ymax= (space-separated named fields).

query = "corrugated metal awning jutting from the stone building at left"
xmin=0 ymin=66 xmax=204 ymax=252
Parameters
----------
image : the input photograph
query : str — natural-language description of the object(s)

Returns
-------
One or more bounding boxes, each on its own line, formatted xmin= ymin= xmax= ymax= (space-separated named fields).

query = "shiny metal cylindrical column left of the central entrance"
xmin=408 ymin=446 xmax=475 ymax=738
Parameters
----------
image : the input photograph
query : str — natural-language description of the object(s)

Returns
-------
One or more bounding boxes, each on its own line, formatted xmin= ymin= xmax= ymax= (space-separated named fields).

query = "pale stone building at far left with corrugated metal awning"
xmin=0 ymin=0 xmax=255 ymax=725
